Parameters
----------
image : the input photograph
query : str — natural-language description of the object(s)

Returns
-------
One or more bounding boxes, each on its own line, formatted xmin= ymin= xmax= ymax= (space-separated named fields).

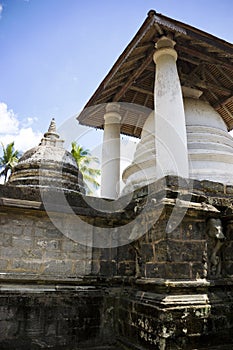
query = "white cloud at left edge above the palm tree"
xmin=0 ymin=102 xmax=42 ymax=152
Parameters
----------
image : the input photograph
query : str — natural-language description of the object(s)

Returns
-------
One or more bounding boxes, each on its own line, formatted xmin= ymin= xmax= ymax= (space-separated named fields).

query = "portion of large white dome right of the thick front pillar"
xmin=184 ymin=98 xmax=233 ymax=185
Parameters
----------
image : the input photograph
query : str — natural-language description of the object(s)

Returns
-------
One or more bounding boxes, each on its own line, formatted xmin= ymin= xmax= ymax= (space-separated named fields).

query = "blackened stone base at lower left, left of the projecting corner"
xmin=0 ymin=285 xmax=113 ymax=350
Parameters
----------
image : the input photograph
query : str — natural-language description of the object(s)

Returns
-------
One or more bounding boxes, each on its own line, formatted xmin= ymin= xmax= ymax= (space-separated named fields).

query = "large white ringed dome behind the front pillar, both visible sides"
xmin=122 ymin=93 xmax=233 ymax=193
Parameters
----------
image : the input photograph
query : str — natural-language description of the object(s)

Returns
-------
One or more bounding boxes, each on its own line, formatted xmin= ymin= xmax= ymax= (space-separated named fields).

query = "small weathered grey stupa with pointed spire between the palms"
xmin=8 ymin=119 xmax=85 ymax=193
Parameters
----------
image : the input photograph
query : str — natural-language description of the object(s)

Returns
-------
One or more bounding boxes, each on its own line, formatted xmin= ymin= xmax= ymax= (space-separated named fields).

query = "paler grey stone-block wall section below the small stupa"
xmin=0 ymin=209 xmax=92 ymax=281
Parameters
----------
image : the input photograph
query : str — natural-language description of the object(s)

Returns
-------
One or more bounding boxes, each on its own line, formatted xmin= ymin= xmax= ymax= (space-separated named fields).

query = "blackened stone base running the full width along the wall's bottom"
xmin=0 ymin=279 xmax=233 ymax=350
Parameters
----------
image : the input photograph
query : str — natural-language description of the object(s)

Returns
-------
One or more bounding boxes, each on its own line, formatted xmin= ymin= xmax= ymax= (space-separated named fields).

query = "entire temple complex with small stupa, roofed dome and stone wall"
xmin=0 ymin=11 xmax=233 ymax=350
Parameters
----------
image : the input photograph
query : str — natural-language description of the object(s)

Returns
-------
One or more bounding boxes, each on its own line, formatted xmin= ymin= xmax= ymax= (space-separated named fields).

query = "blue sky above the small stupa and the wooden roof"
xmin=0 ymin=0 xmax=233 ymax=150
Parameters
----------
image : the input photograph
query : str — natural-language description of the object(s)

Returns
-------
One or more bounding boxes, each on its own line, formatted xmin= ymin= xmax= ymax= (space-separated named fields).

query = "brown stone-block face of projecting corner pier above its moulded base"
xmin=135 ymin=215 xmax=206 ymax=280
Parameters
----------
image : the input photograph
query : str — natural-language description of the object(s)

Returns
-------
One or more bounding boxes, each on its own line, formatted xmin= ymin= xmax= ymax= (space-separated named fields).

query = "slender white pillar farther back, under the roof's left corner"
xmin=101 ymin=103 xmax=121 ymax=199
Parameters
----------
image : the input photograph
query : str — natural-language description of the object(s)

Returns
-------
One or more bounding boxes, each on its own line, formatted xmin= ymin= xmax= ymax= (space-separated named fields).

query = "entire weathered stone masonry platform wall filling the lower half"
xmin=0 ymin=177 xmax=233 ymax=349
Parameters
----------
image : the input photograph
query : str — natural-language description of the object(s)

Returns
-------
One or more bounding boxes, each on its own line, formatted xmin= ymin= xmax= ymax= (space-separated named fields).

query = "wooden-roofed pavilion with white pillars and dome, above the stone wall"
xmin=78 ymin=11 xmax=233 ymax=198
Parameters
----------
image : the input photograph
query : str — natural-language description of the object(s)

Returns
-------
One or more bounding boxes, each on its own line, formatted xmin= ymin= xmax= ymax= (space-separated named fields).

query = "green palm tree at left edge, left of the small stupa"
xmin=0 ymin=141 xmax=20 ymax=183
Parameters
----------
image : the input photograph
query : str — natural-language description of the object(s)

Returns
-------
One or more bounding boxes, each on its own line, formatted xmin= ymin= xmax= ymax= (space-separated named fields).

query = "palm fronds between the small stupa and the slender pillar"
xmin=71 ymin=142 xmax=100 ymax=194
